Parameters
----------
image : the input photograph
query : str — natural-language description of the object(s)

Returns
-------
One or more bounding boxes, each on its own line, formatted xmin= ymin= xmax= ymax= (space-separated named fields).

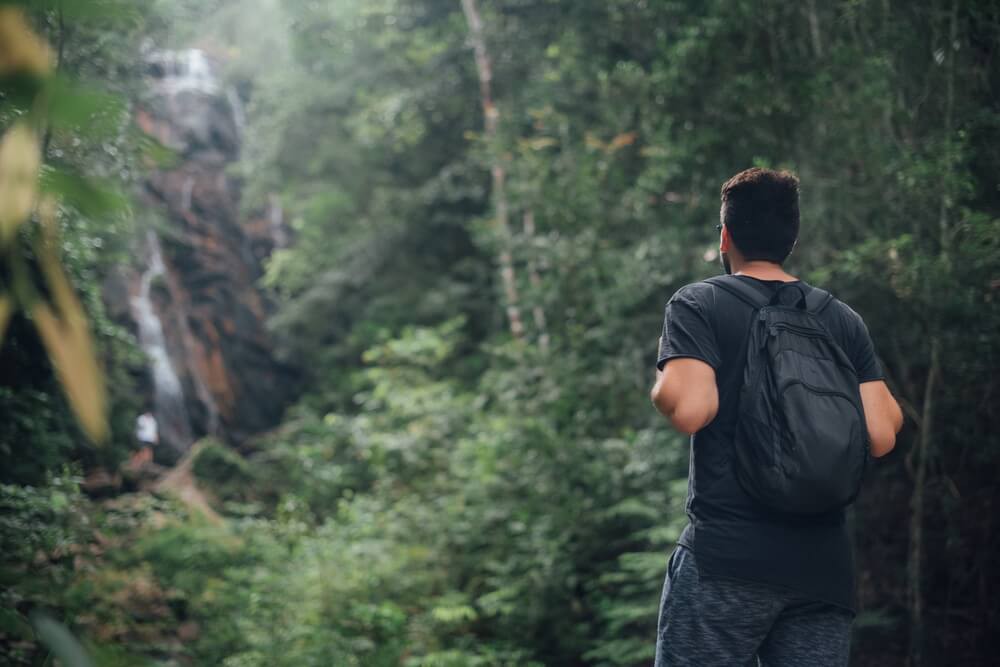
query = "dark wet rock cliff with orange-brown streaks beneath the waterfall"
xmin=121 ymin=50 xmax=294 ymax=459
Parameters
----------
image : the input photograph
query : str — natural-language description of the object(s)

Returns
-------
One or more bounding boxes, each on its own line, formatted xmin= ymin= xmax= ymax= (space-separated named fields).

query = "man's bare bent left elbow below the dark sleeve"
xmin=649 ymin=357 xmax=719 ymax=434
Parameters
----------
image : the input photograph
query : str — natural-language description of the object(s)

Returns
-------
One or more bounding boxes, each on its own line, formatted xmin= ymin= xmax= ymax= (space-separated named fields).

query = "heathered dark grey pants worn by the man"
xmin=655 ymin=546 xmax=854 ymax=667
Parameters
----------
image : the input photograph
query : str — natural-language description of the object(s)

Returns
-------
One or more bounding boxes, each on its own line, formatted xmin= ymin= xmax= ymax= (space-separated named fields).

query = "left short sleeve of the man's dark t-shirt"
xmin=656 ymin=286 xmax=722 ymax=370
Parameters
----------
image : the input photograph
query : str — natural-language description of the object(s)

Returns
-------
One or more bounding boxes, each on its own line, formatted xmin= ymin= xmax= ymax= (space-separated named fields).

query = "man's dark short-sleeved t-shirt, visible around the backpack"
xmin=656 ymin=276 xmax=882 ymax=610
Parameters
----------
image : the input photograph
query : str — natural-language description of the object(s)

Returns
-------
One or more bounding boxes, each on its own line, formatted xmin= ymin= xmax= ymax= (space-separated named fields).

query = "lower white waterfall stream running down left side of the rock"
xmin=130 ymin=230 xmax=193 ymax=450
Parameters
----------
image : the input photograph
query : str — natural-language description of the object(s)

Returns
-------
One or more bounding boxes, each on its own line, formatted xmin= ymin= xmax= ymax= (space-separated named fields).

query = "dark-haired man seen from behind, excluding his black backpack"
xmin=651 ymin=168 xmax=903 ymax=667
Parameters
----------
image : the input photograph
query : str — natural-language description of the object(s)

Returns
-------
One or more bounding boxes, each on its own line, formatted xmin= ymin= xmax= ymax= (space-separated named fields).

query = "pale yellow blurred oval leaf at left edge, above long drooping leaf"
xmin=0 ymin=123 xmax=42 ymax=245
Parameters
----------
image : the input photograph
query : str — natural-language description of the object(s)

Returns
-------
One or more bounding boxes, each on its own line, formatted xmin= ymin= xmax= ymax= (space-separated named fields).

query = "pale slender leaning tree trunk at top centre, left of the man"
xmin=462 ymin=0 xmax=524 ymax=338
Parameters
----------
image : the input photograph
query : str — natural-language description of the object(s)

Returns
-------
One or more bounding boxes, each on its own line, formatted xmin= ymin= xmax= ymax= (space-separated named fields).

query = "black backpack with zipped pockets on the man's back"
xmin=706 ymin=276 xmax=869 ymax=515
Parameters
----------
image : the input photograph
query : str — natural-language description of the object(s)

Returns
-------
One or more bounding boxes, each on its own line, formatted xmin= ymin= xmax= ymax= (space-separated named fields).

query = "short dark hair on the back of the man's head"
xmin=721 ymin=167 xmax=799 ymax=264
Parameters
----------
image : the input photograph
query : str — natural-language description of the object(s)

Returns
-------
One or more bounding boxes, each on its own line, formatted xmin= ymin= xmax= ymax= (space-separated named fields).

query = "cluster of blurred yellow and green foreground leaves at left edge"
xmin=0 ymin=6 xmax=109 ymax=442
